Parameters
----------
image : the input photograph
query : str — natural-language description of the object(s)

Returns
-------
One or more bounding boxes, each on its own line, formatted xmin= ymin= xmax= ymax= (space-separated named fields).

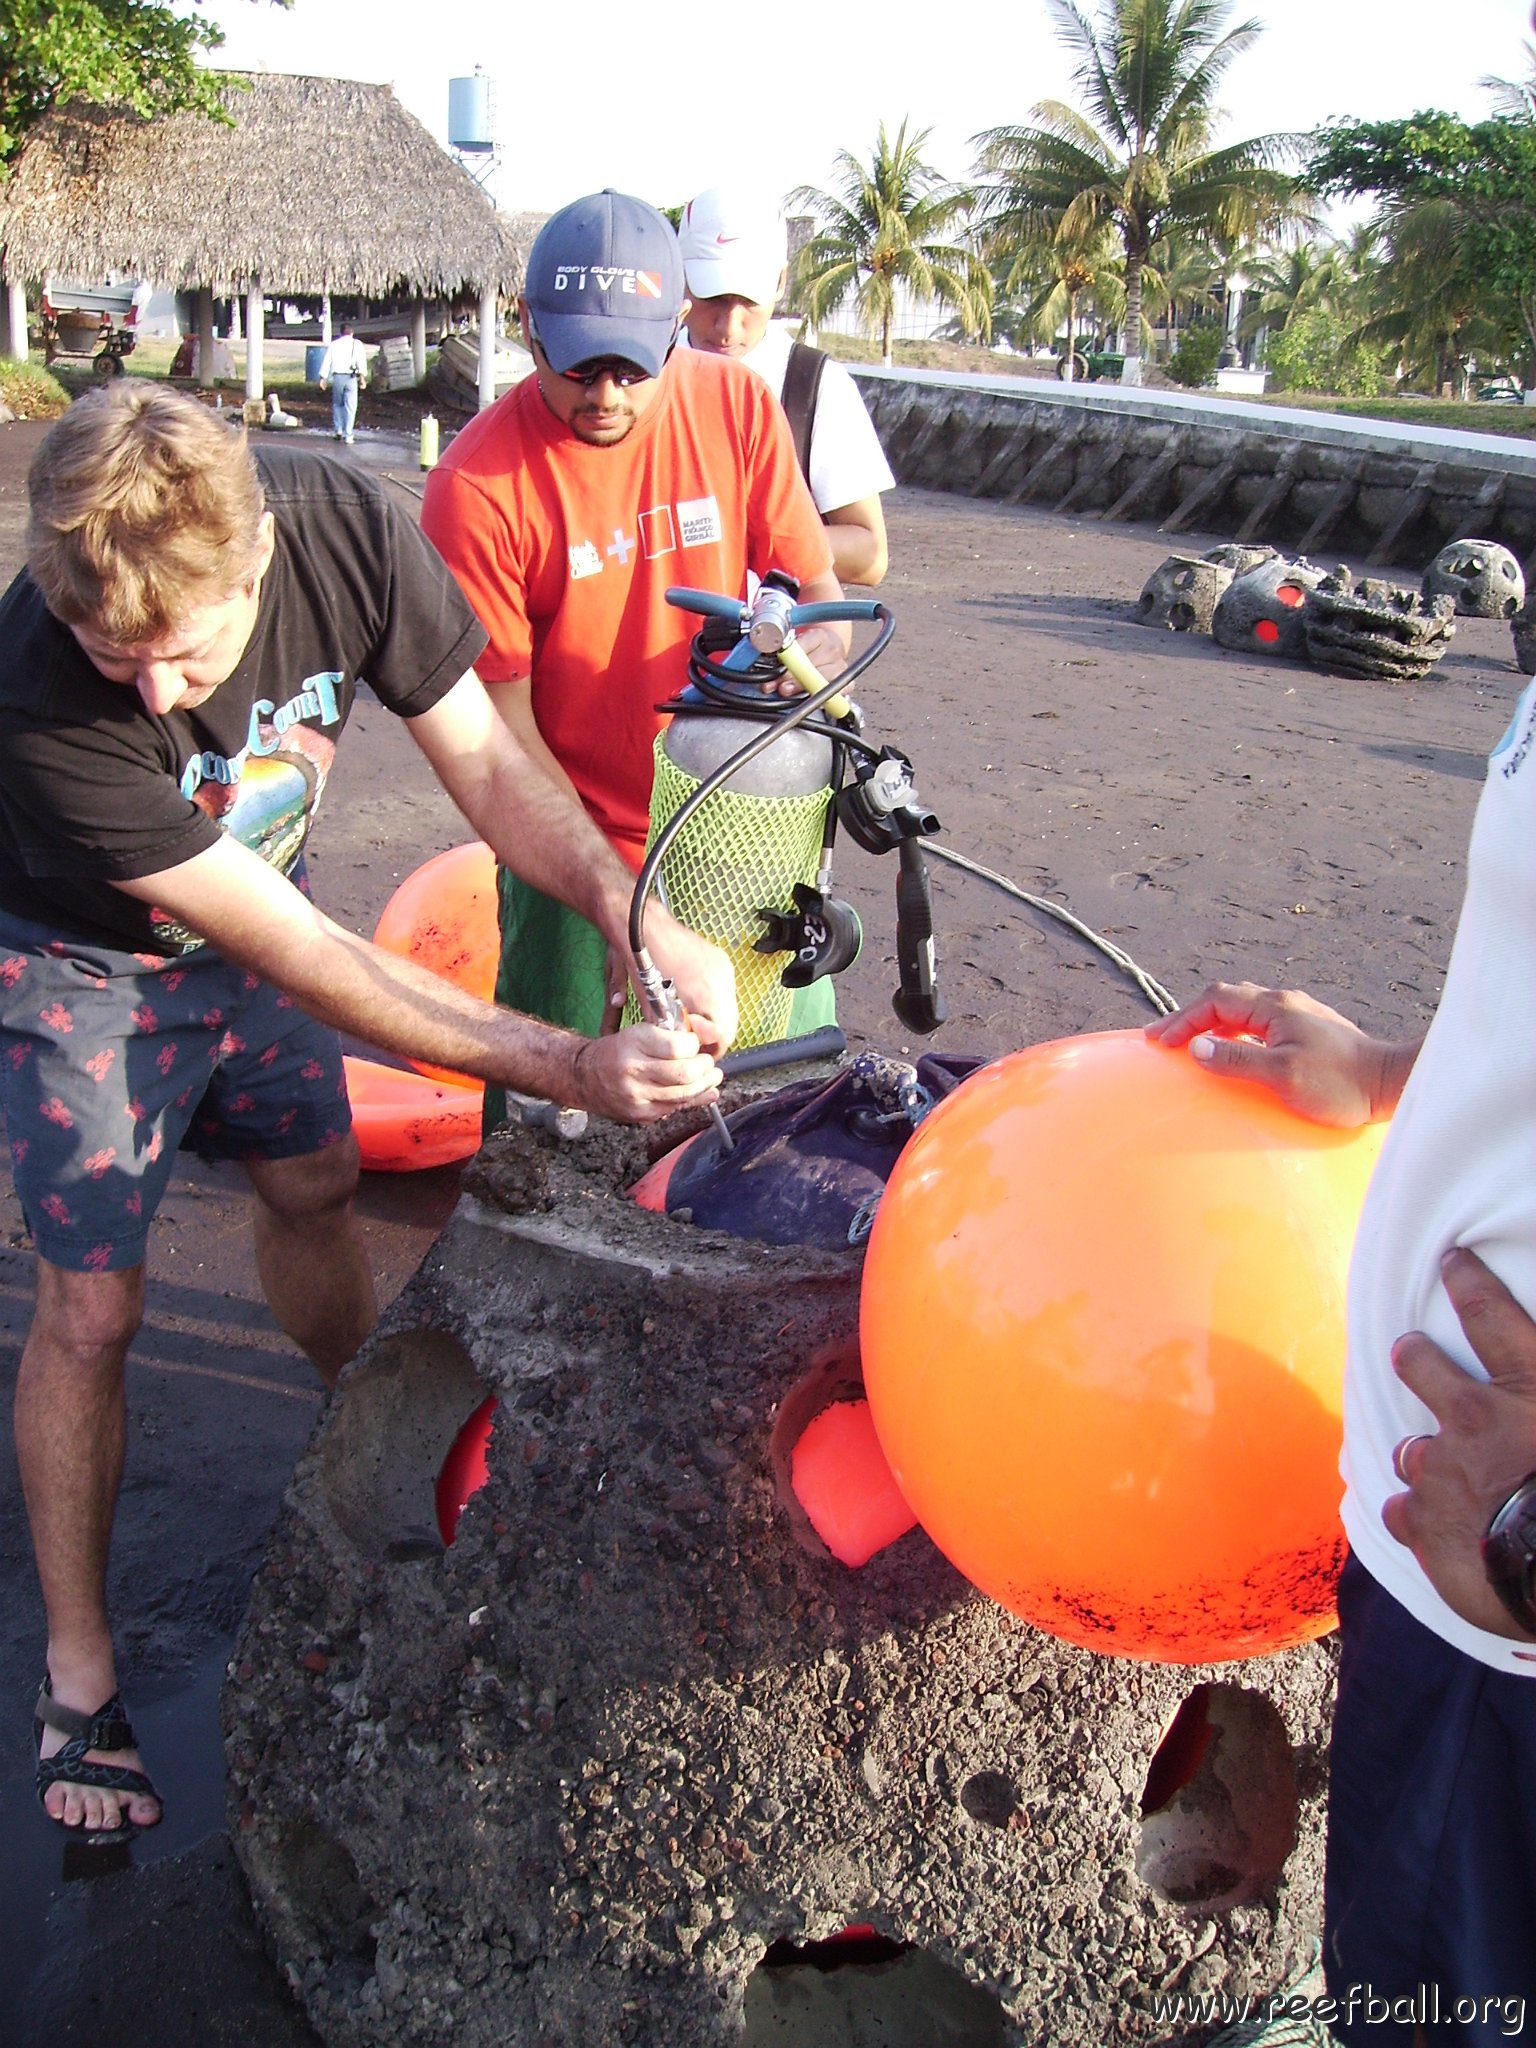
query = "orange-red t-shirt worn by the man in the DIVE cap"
xmin=422 ymin=348 xmax=831 ymax=854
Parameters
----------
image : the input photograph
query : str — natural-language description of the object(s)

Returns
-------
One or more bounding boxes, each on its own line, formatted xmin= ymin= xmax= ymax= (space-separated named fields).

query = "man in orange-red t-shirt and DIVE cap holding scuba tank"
xmin=422 ymin=193 xmax=848 ymax=1114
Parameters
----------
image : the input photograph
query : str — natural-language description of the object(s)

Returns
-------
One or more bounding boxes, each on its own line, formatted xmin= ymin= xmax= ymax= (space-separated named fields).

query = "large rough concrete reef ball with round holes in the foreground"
xmin=225 ymin=1130 xmax=1333 ymax=2048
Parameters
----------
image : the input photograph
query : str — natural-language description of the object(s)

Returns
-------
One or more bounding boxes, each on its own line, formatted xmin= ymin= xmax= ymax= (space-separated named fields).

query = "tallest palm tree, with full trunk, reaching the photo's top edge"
xmin=977 ymin=0 xmax=1296 ymax=383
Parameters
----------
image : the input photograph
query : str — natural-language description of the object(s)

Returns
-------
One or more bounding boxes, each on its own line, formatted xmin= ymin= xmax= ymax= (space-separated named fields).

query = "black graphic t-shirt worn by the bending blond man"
xmin=0 ymin=449 xmax=485 ymax=954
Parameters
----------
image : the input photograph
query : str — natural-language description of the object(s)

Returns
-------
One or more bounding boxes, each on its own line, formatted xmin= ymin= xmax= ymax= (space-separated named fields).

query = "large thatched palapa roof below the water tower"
xmin=0 ymin=72 xmax=526 ymax=297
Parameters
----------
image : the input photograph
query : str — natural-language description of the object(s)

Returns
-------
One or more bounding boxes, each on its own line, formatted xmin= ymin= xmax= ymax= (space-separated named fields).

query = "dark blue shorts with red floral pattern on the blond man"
xmin=0 ymin=913 xmax=352 ymax=1272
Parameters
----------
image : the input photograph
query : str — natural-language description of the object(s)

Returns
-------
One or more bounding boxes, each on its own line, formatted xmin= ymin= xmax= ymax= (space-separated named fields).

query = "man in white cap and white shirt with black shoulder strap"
xmin=678 ymin=186 xmax=895 ymax=584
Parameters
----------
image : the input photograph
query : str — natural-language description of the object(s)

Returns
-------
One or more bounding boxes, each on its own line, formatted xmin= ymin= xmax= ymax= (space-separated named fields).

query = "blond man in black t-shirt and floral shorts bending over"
xmin=0 ymin=379 xmax=735 ymax=1835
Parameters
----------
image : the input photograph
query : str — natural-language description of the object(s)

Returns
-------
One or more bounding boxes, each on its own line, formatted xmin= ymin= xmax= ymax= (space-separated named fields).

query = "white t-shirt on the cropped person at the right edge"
xmin=1341 ymin=682 xmax=1536 ymax=1677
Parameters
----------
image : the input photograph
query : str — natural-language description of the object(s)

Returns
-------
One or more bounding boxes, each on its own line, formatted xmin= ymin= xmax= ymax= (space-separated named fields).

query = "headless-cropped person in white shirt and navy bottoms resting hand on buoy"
xmin=1147 ymin=682 xmax=1536 ymax=2048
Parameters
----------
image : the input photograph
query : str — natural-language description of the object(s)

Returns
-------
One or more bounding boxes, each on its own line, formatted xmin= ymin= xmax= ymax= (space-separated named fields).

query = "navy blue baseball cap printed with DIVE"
xmin=522 ymin=193 xmax=684 ymax=377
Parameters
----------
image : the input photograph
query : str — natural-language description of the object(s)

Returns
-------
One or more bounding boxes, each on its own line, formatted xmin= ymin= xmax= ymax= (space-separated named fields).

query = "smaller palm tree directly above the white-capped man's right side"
xmin=791 ymin=121 xmax=991 ymax=365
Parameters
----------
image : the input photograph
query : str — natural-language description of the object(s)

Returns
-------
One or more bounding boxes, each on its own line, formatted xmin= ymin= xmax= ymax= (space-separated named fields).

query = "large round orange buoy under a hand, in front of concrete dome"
xmin=860 ymin=1032 xmax=1382 ymax=1663
